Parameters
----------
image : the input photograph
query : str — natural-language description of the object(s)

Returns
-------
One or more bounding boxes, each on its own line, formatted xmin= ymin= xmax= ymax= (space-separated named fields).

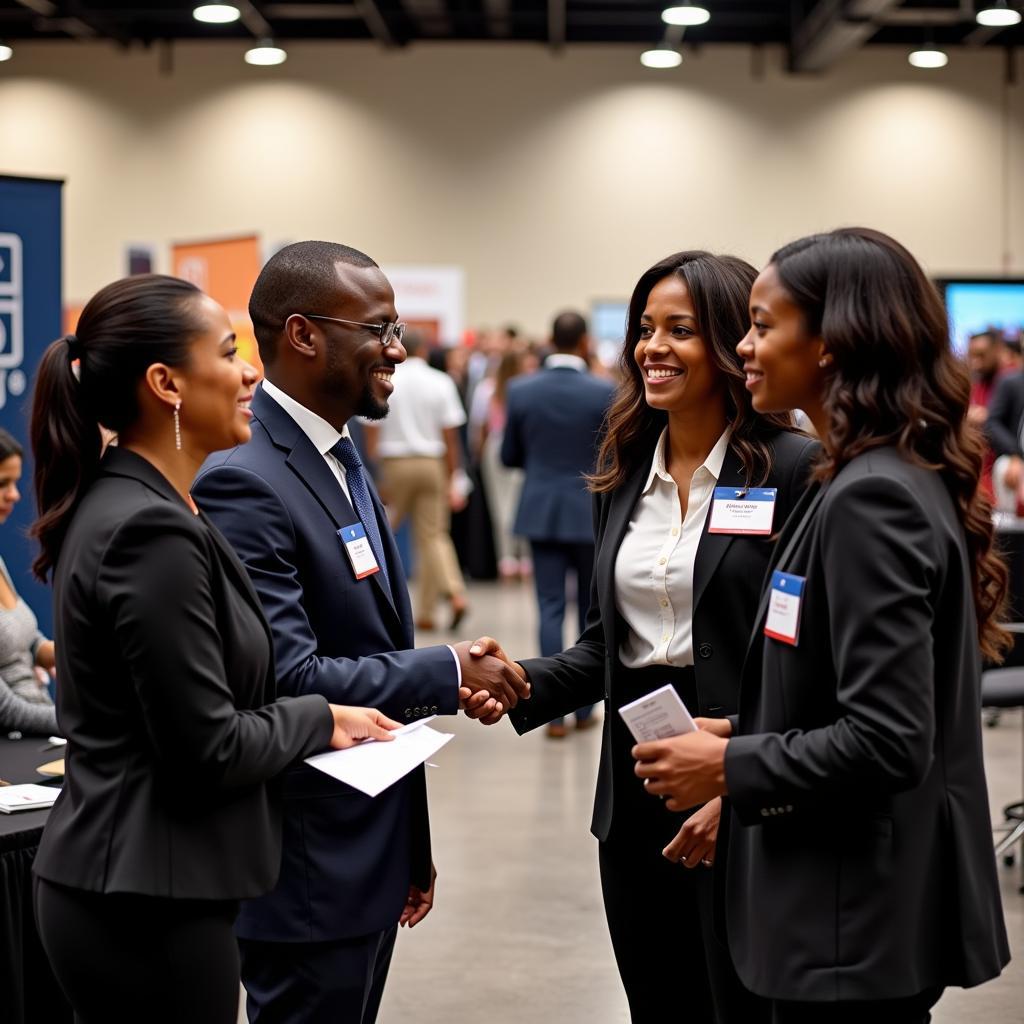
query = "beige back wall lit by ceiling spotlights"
xmin=0 ymin=43 xmax=1024 ymax=331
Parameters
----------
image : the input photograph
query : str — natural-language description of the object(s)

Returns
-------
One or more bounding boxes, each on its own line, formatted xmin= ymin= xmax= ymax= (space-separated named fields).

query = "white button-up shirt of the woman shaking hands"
xmin=615 ymin=427 xmax=731 ymax=669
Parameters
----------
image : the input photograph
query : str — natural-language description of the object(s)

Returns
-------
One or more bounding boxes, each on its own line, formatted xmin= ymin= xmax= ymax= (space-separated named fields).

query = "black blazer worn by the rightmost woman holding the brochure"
xmin=725 ymin=449 xmax=1010 ymax=1000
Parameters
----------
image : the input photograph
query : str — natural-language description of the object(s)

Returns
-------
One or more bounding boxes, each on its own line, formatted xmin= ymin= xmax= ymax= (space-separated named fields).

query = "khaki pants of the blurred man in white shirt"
xmin=380 ymin=456 xmax=466 ymax=621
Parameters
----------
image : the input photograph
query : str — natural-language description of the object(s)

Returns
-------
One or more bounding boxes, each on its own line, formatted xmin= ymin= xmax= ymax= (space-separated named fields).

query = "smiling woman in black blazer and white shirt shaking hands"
xmin=468 ymin=252 xmax=816 ymax=1024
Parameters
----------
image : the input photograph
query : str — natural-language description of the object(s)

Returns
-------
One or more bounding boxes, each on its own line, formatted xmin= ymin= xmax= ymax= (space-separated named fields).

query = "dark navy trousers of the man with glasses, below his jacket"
xmin=239 ymin=925 xmax=398 ymax=1024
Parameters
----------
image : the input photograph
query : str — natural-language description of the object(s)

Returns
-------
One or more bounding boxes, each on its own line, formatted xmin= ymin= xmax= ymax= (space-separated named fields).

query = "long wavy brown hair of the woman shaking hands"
xmin=588 ymin=250 xmax=794 ymax=493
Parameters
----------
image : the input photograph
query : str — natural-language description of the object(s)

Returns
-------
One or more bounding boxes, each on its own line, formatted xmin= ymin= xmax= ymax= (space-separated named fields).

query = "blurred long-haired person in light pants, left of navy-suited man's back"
xmin=475 ymin=347 xmax=538 ymax=580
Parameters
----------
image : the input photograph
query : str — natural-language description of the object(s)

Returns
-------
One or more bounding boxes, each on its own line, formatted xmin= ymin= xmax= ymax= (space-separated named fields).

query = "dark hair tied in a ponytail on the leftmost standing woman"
xmin=31 ymin=273 xmax=203 ymax=582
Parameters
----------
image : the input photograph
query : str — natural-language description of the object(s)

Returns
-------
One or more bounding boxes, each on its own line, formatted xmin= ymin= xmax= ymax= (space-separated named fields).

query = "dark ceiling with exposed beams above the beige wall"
xmin=0 ymin=0 xmax=1024 ymax=71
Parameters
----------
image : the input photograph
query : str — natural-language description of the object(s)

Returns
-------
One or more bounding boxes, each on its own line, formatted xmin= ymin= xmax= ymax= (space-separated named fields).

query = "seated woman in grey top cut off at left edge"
xmin=0 ymin=429 xmax=57 ymax=735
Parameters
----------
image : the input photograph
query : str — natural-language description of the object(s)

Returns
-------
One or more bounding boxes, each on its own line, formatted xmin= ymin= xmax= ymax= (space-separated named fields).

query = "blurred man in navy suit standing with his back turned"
xmin=502 ymin=312 xmax=613 ymax=737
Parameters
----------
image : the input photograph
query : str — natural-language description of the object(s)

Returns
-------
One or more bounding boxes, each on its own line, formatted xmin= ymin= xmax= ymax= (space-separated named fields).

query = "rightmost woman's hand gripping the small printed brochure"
xmin=633 ymin=729 xmax=729 ymax=811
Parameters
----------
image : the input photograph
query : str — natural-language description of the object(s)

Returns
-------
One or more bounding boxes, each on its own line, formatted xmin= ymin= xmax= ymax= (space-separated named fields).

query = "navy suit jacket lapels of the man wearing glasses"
xmin=252 ymin=387 xmax=402 ymax=615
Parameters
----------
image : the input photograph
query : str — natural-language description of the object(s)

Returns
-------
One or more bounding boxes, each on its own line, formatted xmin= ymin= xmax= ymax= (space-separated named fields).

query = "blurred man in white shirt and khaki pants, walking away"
xmin=362 ymin=331 xmax=469 ymax=630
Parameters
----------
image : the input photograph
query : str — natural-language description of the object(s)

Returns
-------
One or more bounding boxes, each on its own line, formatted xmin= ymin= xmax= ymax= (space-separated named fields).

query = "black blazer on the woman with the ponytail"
xmin=34 ymin=447 xmax=333 ymax=899
